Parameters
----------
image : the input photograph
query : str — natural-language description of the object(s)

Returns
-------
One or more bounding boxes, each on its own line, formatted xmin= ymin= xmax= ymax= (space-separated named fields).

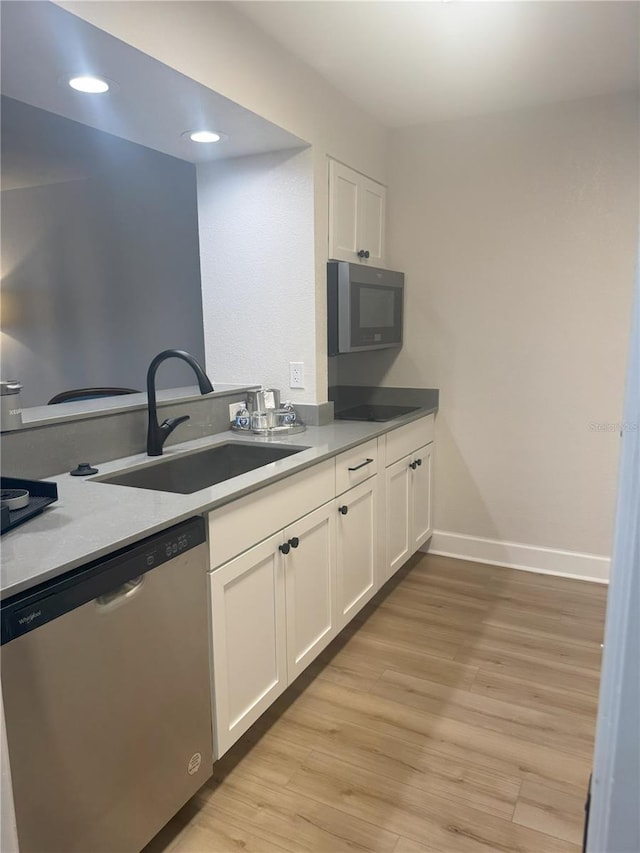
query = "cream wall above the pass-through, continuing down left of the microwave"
xmin=59 ymin=0 xmax=388 ymax=402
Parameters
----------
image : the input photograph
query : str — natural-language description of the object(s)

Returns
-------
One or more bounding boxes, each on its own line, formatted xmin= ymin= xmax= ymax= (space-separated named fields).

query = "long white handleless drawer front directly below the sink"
xmin=209 ymin=459 xmax=335 ymax=569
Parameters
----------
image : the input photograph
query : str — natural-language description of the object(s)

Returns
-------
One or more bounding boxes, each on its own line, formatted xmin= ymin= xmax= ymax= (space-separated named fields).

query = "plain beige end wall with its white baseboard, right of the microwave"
xmin=383 ymin=97 xmax=639 ymax=576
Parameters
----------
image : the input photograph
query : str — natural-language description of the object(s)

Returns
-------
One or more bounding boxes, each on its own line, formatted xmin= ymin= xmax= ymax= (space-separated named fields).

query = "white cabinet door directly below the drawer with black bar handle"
xmin=335 ymin=477 xmax=378 ymax=630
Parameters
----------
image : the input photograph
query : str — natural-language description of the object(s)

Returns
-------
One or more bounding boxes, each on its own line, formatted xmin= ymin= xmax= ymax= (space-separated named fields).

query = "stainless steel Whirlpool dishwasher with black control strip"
xmin=2 ymin=518 xmax=213 ymax=853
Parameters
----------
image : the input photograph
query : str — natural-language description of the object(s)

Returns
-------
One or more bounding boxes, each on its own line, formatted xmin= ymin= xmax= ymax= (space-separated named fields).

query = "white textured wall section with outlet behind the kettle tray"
xmin=197 ymin=148 xmax=316 ymax=403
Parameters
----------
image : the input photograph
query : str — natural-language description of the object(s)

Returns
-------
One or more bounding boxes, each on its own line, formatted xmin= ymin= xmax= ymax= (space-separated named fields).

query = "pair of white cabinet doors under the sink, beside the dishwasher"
xmin=209 ymin=501 xmax=338 ymax=758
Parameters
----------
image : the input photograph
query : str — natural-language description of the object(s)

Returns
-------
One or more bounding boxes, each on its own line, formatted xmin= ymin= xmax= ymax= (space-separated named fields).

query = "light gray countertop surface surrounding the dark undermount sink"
xmin=0 ymin=408 xmax=434 ymax=599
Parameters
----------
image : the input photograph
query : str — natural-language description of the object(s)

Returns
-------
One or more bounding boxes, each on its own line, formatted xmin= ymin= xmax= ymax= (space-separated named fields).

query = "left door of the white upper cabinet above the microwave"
xmin=329 ymin=160 xmax=360 ymax=262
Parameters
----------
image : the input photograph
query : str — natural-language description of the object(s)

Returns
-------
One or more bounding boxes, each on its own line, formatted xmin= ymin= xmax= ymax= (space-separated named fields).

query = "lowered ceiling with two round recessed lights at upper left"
xmin=0 ymin=0 xmax=304 ymax=166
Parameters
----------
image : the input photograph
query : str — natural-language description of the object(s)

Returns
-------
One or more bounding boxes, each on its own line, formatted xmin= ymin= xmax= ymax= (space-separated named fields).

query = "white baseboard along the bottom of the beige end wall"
xmin=423 ymin=530 xmax=611 ymax=583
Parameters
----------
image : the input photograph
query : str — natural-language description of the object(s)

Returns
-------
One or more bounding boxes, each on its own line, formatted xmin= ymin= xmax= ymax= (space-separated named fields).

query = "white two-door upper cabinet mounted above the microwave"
xmin=329 ymin=159 xmax=387 ymax=267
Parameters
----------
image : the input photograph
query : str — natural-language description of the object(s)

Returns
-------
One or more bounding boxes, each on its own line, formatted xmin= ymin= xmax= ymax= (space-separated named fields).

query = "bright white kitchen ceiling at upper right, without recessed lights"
xmin=233 ymin=0 xmax=640 ymax=127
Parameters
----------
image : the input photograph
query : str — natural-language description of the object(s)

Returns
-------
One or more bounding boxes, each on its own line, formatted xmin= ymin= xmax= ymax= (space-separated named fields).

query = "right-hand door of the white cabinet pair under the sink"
xmin=283 ymin=501 xmax=337 ymax=683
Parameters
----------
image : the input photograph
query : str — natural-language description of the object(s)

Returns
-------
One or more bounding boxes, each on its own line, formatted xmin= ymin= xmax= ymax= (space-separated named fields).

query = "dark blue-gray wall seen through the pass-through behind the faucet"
xmin=2 ymin=98 xmax=204 ymax=406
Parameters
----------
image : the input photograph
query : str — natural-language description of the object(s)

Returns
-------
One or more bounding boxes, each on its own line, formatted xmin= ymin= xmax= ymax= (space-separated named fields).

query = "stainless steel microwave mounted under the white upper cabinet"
xmin=327 ymin=261 xmax=404 ymax=355
